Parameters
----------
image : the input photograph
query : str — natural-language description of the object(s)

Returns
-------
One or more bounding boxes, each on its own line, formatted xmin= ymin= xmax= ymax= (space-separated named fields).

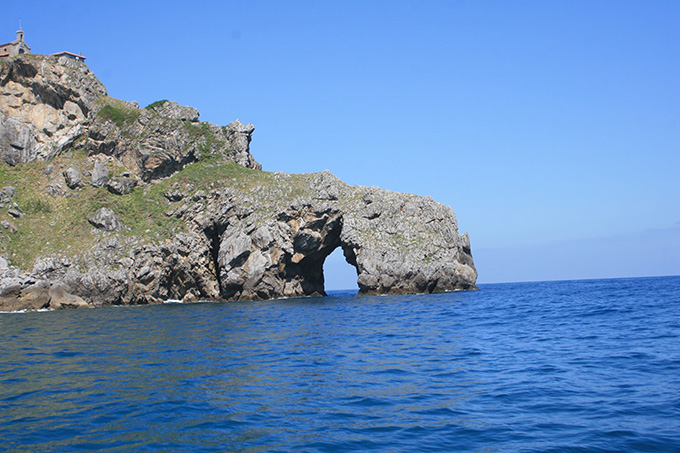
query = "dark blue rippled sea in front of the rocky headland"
xmin=0 ymin=277 xmax=680 ymax=452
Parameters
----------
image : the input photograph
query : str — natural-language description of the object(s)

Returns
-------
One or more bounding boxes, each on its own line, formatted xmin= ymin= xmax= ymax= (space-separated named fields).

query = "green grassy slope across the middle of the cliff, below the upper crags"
xmin=0 ymin=150 xmax=308 ymax=270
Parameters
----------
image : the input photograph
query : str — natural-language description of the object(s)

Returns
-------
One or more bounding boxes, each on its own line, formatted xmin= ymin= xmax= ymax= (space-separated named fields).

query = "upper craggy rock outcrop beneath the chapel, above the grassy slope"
xmin=0 ymin=55 xmax=262 ymax=177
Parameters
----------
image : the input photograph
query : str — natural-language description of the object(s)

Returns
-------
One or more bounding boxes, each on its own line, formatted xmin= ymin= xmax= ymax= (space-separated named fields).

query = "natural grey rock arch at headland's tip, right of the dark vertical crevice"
xmin=209 ymin=178 xmax=476 ymax=300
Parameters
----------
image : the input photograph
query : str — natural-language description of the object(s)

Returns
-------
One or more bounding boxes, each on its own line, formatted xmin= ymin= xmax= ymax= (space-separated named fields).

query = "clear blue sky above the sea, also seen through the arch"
xmin=0 ymin=0 xmax=680 ymax=289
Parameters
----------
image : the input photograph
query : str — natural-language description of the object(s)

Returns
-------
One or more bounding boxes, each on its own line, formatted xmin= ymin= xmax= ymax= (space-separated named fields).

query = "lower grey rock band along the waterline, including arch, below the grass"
xmin=0 ymin=168 xmax=477 ymax=307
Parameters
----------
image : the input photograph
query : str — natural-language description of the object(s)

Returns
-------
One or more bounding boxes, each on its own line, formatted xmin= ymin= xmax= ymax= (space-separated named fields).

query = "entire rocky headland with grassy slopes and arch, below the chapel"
xmin=0 ymin=56 xmax=477 ymax=310
